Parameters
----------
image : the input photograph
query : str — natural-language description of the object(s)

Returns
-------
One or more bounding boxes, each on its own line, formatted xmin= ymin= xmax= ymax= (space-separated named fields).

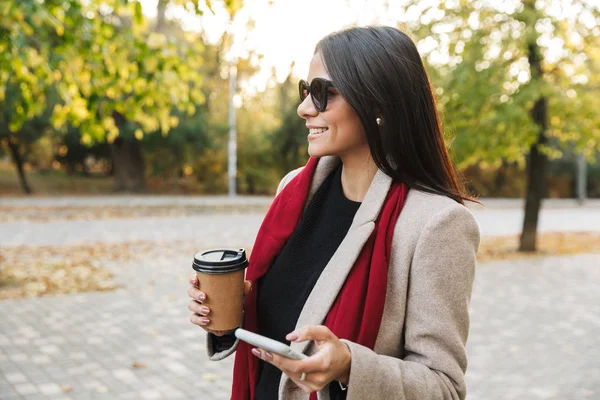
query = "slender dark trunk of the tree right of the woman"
xmin=519 ymin=37 xmax=548 ymax=251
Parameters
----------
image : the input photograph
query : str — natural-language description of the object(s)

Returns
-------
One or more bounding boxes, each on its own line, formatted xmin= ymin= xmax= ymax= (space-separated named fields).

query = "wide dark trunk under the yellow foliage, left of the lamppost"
xmin=110 ymin=138 xmax=146 ymax=193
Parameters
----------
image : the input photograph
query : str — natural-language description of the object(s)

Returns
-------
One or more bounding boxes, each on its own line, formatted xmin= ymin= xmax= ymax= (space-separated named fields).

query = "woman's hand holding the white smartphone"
xmin=252 ymin=325 xmax=352 ymax=393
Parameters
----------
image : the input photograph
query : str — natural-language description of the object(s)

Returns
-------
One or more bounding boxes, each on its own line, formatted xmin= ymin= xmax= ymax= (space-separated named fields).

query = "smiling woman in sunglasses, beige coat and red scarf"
xmin=189 ymin=27 xmax=479 ymax=400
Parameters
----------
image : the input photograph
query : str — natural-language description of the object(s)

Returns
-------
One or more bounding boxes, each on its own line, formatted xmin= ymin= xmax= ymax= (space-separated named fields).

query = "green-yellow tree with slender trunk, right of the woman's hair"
xmin=404 ymin=0 xmax=600 ymax=251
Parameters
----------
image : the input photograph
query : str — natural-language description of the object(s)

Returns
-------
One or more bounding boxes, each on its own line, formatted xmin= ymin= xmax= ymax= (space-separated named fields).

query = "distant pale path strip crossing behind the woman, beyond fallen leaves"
xmin=0 ymin=196 xmax=600 ymax=247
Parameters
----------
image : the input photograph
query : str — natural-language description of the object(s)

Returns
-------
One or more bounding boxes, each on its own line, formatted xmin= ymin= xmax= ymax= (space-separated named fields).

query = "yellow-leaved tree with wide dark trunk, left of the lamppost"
xmin=0 ymin=0 xmax=213 ymax=190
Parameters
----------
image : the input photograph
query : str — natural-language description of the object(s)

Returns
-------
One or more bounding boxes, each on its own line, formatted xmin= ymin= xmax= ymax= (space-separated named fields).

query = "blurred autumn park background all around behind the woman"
xmin=0 ymin=0 xmax=600 ymax=399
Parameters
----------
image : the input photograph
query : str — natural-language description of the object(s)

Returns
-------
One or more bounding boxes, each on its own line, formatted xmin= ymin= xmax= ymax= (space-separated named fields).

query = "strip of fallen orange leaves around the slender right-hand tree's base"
xmin=477 ymin=232 xmax=600 ymax=262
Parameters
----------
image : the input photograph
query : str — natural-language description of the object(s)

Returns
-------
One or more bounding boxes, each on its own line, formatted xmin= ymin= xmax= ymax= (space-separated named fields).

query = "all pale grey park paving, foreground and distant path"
xmin=0 ymin=198 xmax=600 ymax=400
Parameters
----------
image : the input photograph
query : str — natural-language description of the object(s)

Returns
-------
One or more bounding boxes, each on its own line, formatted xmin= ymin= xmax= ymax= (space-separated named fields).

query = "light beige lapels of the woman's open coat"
xmin=279 ymin=157 xmax=392 ymax=399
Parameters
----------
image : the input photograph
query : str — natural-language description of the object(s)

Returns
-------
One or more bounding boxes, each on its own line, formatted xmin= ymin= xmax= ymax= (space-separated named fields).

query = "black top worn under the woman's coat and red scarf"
xmin=256 ymin=165 xmax=361 ymax=400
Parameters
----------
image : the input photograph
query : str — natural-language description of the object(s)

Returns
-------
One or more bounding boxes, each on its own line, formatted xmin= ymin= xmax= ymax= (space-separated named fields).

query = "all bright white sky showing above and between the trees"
xmin=141 ymin=0 xmax=600 ymax=96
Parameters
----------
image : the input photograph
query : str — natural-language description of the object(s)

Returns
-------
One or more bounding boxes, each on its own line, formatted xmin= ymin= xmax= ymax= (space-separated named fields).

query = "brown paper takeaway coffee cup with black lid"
xmin=192 ymin=249 xmax=248 ymax=331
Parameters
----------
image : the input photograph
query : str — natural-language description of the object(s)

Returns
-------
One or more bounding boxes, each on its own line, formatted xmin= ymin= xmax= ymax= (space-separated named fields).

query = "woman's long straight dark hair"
xmin=315 ymin=26 xmax=476 ymax=204
